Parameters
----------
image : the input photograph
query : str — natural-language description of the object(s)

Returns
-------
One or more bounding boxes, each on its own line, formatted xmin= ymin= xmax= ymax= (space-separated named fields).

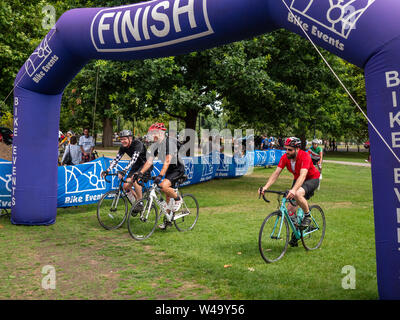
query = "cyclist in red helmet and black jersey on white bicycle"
xmin=139 ymin=123 xmax=185 ymax=229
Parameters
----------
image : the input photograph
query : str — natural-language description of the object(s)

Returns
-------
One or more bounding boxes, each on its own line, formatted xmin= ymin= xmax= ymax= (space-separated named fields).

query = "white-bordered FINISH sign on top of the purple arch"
xmin=90 ymin=0 xmax=213 ymax=52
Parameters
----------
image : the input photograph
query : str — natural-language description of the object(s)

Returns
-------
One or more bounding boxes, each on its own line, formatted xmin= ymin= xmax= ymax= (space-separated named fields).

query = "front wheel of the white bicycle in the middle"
xmin=127 ymin=198 xmax=158 ymax=241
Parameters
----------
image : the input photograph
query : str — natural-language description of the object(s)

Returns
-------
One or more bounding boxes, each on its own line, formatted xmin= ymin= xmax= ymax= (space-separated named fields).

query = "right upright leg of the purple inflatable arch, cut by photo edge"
xmin=365 ymin=39 xmax=400 ymax=299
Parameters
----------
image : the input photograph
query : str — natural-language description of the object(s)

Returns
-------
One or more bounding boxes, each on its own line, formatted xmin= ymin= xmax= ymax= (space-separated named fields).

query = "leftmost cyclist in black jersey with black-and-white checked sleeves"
xmin=101 ymin=130 xmax=152 ymax=208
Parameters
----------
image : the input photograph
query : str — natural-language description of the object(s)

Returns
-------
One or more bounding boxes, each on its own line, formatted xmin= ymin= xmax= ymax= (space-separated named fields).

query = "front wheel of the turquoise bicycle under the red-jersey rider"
xmin=258 ymin=211 xmax=289 ymax=263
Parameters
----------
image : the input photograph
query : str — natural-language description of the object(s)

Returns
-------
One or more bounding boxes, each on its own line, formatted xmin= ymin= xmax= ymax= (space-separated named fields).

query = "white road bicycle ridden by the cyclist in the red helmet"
xmin=127 ymin=176 xmax=199 ymax=241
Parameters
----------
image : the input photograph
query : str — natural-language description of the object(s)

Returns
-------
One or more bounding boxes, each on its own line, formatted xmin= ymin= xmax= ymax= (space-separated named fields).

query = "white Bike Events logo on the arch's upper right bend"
xmin=288 ymin=0 xmax=375 ymax=51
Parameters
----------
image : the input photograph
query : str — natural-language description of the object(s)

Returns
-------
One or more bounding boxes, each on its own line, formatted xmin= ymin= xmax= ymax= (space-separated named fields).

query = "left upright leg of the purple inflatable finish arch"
xmin=11 ymin=87 xmax=62 ymax=225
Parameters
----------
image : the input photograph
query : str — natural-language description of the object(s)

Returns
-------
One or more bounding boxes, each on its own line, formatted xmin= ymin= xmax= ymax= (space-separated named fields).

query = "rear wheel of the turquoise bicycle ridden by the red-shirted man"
xmin=301 ymin=205 xmax=326 ymax=250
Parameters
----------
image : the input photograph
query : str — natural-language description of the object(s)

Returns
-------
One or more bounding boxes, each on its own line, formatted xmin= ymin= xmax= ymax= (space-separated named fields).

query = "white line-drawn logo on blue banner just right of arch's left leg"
xmin=64 ymin=161 xmax=106 ymax=194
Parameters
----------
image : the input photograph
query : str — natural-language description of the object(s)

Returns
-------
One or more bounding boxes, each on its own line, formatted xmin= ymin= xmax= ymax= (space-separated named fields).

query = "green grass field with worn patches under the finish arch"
xmin=0 ymin=163 xmax=378 ymax=299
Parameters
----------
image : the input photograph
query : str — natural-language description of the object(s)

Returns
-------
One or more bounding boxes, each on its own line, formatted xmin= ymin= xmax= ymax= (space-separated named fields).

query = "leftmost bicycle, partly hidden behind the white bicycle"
xmin=97 ymin=171 xmax=136 ymax=230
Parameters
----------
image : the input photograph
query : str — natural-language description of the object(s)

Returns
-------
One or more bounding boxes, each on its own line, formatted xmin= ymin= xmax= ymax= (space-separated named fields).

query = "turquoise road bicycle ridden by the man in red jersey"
xmin=258 ymin=190 xmax=326 ymax=263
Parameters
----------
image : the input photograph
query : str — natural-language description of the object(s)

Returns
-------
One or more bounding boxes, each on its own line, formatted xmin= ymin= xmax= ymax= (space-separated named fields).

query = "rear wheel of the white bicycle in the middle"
xmin=174 ymin=193 xmax=199 ymax=232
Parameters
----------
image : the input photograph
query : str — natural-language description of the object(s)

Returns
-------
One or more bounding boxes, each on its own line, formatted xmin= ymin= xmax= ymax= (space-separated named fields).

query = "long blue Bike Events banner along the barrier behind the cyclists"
xmin=0 ymin=150 xmax=284 ymax=208
